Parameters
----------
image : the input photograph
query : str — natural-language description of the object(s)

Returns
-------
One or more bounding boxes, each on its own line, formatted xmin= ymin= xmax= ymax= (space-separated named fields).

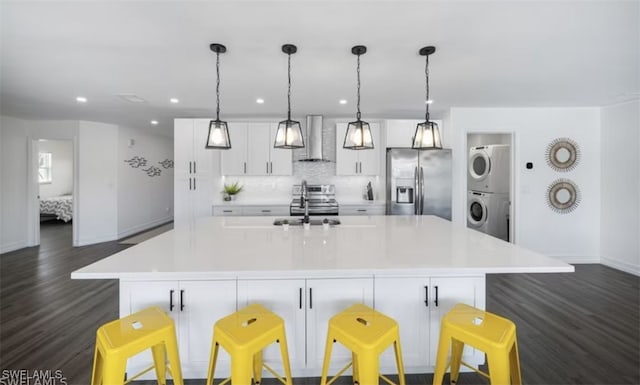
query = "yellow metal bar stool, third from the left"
xmin=320 ymin=304 xmax=405 ymax=385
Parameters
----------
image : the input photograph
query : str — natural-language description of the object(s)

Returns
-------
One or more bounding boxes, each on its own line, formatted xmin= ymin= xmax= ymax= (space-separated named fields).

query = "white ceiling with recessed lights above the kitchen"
xmin=0 ymin=0 xmax=640 ymax=134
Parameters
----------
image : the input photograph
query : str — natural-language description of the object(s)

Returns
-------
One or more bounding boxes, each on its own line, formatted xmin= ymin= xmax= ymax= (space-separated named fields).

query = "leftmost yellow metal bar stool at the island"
xmin=91 ymin=307 xmax=183 ymax=385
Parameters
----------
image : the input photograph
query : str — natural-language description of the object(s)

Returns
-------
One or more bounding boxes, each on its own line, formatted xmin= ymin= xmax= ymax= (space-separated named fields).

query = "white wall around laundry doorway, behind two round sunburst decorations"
xmin=447 ymin=108 xmax=600 ymax=262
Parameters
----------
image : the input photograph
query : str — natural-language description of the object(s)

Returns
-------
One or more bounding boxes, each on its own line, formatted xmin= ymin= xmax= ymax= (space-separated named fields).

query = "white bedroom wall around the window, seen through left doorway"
xmin=38 ymin=140 xmax=73 ymax=198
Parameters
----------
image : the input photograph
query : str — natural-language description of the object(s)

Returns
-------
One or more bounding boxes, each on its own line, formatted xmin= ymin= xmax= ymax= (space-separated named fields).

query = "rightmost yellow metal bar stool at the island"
xmin=433 ymin=303 xmax=522 ymax=385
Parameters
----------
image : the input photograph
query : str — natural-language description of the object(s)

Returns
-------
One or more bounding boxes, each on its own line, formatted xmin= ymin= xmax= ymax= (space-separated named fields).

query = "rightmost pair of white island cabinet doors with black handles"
xmin=375 ymin=276 xmax=484 ymax=372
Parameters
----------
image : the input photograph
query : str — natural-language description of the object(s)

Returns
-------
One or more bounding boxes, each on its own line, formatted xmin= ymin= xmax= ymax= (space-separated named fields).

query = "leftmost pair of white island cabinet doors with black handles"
xmin=120 ymin=280 xmax=236 ymax=378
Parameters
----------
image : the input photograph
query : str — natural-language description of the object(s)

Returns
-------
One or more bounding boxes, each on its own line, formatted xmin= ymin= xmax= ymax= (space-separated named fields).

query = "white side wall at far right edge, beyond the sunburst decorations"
xmin=600 ymin=100 xmax=640 ymax=275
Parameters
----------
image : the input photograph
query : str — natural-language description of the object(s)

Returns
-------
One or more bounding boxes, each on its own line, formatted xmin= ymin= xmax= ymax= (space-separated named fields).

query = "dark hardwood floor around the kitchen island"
xmin=0 ymin=222 xmax=640 ymax=385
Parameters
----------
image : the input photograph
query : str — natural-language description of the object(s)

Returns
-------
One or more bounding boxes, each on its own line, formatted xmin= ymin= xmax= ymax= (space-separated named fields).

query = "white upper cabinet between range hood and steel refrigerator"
xmin=336 ymin=123 xmax=382 ymax=175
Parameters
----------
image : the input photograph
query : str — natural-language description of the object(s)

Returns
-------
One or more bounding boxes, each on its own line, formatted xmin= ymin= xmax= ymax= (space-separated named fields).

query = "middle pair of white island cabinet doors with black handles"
xmin=238 ymin=278 xmax=373 ymax=376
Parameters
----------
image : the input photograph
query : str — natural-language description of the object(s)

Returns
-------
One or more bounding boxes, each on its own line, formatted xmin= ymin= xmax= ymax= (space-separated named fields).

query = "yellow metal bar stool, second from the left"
xmin=207 ymin=304 xmax=293 ymax=385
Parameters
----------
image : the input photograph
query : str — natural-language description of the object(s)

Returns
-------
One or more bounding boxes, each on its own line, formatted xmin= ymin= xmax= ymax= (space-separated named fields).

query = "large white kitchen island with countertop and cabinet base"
xmin=71 ymin=216 xmax=574 ymax=378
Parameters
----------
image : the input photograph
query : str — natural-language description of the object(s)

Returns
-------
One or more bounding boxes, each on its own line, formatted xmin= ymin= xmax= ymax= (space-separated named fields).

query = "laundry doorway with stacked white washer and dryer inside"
xmin=466 ymin=132 xmax=516 ymax=243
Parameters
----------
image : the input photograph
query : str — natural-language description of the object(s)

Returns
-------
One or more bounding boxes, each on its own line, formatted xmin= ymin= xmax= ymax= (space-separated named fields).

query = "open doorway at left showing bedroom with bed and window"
xmin=29 ymin=139 xmax=77 ymax=247
